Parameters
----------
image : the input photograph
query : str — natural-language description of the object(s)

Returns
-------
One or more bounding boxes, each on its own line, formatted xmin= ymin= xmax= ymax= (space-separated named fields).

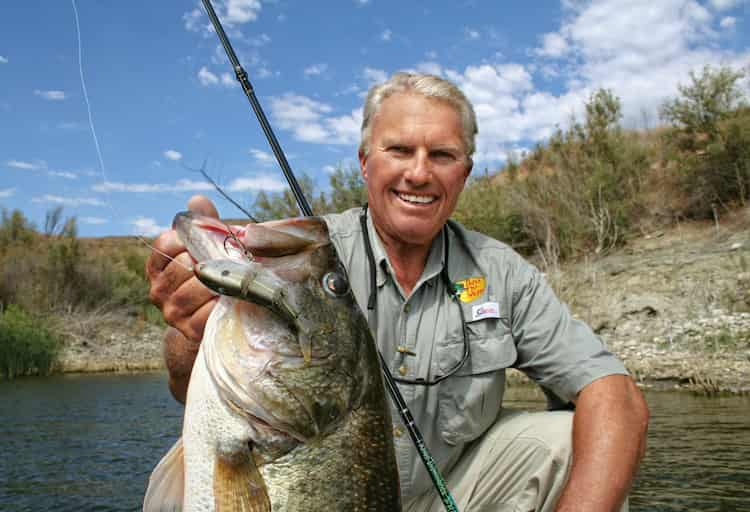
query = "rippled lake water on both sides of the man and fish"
xmin=0 ymin=373 xmax=750 ymax=512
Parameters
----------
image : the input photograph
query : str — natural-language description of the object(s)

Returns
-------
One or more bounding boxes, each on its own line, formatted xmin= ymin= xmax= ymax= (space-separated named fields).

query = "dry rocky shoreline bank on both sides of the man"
xmin=58 ymin=207 xmax=750 ymax=394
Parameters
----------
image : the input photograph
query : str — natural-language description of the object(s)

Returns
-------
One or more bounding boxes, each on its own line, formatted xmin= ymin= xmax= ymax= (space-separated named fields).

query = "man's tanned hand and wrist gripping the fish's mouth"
xmin=146 ymin=196 xmax=219 ymax=403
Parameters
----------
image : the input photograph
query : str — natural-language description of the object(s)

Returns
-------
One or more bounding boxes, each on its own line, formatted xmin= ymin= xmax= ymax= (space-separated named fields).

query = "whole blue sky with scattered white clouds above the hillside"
xmin=0 ymin=0 xmax=750 ymax=236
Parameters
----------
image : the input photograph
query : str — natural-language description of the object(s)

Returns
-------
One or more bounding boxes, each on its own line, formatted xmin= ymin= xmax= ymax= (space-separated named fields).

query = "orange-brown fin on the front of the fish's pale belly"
xmin=214 ymin=453 xmax=271 ymax=512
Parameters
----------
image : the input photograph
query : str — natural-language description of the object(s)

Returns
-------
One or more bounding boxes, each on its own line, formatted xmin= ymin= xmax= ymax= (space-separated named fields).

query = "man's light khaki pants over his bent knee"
xmin=404 ymin=409 xmax=628 ymax=512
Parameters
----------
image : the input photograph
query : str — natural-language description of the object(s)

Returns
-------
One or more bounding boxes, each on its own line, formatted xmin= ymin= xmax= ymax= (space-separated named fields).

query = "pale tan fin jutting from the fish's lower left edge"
xmin=143 ymin=438 xmax=185 ymax=512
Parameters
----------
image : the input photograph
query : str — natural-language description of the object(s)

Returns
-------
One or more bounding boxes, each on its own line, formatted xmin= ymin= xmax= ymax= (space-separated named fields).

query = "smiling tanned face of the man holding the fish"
xmin=359 ymin=93 xmax=471 ymax=251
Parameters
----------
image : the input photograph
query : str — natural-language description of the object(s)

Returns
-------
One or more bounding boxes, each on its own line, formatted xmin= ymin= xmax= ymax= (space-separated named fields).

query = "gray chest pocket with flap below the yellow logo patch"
xmin=436 ymin=326 xmax=517 ymax=445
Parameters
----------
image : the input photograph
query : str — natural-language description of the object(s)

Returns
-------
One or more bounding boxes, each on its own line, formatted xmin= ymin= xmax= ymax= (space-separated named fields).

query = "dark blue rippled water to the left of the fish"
xmin=0 ymin=373 xmax=182 ymax=511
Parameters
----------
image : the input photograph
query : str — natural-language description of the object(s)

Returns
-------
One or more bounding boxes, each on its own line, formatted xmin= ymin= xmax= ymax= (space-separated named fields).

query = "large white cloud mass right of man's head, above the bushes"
xmin=446 ymin=0 xmax=750 ymax=166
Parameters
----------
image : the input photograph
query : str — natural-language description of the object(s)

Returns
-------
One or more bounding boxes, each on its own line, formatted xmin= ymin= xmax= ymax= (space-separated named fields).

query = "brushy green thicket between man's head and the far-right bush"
xmin=464 ymin=89 xmax=648 ymax=266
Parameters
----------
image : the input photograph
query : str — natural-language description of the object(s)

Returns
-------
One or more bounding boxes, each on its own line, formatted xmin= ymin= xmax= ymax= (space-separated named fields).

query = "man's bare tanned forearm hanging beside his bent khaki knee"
xmin=556 ymin=375 xmax=648 ymax=512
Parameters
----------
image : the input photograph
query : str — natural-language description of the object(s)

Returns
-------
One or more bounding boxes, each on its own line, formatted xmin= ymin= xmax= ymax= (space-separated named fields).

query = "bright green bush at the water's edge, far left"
xmin=0 ymin=305 xmax=60 ymax=379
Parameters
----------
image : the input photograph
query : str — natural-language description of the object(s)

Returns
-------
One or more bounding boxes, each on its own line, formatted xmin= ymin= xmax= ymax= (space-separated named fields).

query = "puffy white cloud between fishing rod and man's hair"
xmin=271 ymin=93 xmax=362 ymax=144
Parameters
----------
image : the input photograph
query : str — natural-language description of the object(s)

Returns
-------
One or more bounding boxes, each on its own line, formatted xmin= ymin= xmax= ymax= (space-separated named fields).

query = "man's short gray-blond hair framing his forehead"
xmin=359 ymin=72 xmax=477 ymax=159
